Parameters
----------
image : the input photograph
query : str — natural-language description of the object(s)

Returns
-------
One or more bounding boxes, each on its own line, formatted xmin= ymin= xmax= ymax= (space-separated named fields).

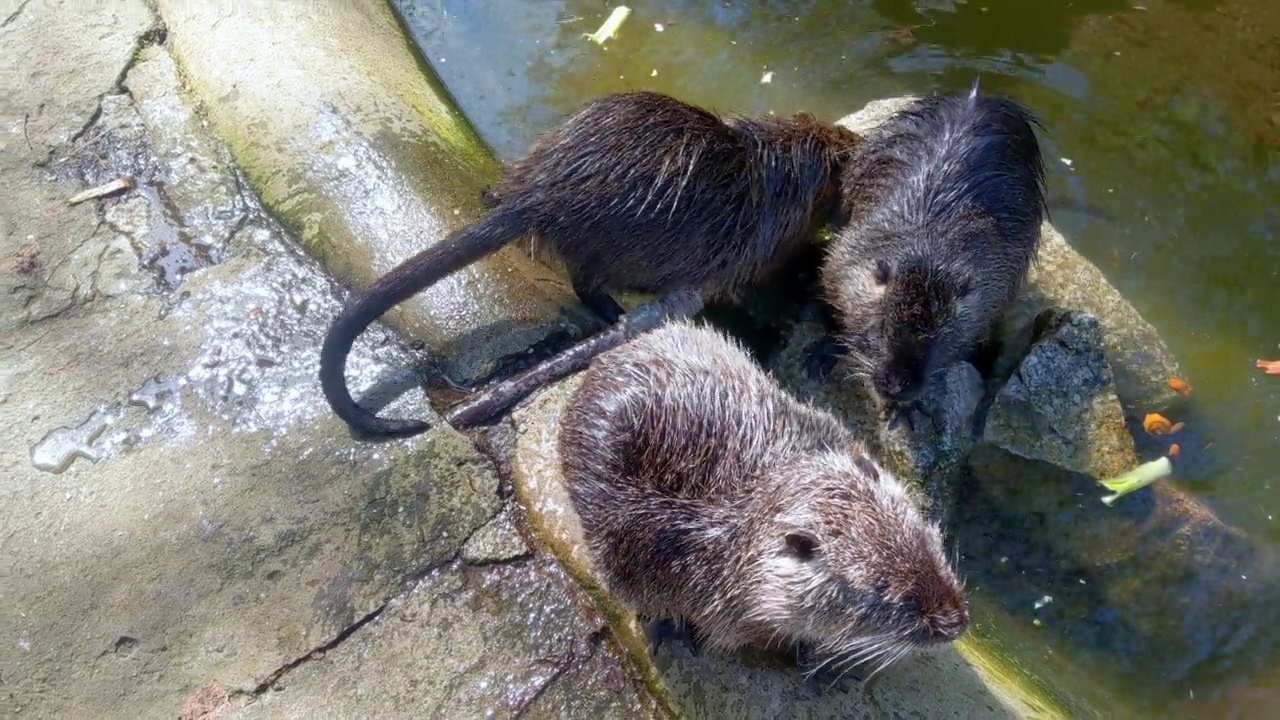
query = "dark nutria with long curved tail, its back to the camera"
xmin=320 ymin=91 xmax=860 ymax=437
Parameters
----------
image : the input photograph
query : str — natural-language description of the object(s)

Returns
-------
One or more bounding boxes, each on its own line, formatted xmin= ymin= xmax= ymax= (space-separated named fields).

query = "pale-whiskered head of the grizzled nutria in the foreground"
xmin=744 ymin=451 xmax=969 ymax=671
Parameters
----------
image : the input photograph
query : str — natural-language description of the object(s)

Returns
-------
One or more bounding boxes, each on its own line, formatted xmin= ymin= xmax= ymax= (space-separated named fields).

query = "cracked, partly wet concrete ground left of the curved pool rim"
xmin=0 ymin=1 xmax=645 ymax=717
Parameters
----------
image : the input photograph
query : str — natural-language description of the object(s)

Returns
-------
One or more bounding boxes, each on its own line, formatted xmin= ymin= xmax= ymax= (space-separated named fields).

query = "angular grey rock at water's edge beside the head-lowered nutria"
xmin=983 ymin=310 xmax=1138 ymax=479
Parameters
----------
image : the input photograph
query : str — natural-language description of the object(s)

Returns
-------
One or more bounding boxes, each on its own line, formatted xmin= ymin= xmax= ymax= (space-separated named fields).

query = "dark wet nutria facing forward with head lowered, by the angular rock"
xmin=820 ymin=82 xmax=1048 ymax=407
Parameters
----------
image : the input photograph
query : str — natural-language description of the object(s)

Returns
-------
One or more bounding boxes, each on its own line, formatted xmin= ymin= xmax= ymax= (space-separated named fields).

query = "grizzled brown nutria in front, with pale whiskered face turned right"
xmin=559 ymin=320 xmax=969 ymax=670
